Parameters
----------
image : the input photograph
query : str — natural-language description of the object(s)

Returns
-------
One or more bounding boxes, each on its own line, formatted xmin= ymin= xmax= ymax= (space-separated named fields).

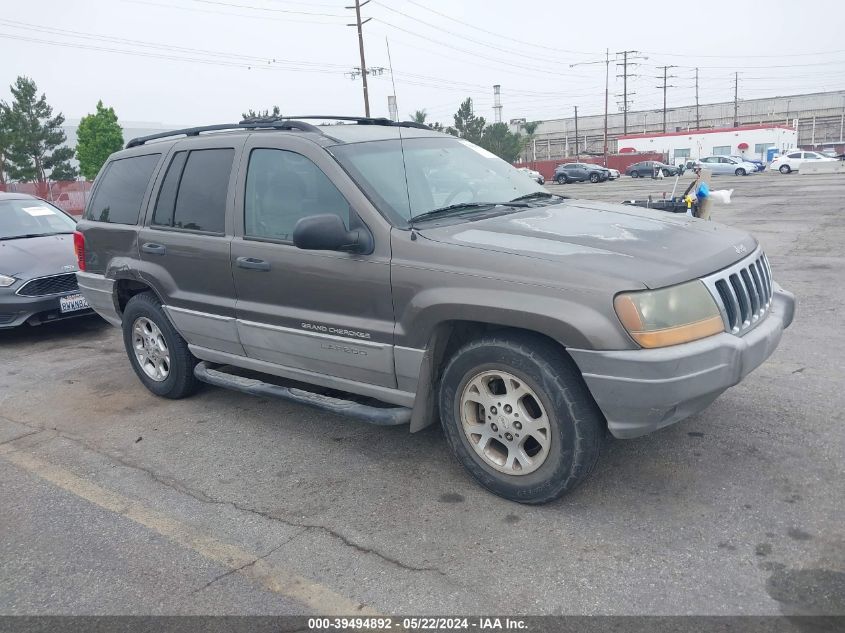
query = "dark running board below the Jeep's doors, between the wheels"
xmin=194 ymin=361 xmax=411 ymax=426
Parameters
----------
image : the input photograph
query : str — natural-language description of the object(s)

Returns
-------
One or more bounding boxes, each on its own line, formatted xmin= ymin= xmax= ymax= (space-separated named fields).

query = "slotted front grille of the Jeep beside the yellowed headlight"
xmin=703 ymin=248 xmax=774 ymax=335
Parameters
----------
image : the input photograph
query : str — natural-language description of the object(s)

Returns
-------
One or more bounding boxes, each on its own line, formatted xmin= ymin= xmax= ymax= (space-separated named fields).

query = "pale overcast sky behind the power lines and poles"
xmin=0 ymin=0 xmax=845 ymax=125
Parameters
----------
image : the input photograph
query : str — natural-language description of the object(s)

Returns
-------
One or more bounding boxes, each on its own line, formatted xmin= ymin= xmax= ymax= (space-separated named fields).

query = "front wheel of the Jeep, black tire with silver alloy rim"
xmin=439 ymin=333 xmax=604 ymax=504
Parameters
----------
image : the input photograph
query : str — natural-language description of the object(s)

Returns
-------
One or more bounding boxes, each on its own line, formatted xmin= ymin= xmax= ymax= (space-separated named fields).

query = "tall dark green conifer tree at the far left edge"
xmin=0 ymin=77 xmax=77 ymax=182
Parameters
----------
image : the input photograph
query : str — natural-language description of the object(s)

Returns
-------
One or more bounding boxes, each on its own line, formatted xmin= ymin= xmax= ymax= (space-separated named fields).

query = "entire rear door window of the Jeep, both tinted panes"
xmin=152 ymin=149 xmax=235 ymax=233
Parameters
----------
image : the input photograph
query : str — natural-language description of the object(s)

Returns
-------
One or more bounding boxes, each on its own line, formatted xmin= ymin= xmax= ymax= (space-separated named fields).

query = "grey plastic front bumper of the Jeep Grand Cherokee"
xmin=568 ymin=285 xmax=795 ymax=438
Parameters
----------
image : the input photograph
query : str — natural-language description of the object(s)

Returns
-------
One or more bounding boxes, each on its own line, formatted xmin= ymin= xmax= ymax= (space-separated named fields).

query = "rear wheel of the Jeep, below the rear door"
xmin=123 ymin=292 xmax=197 ymax=399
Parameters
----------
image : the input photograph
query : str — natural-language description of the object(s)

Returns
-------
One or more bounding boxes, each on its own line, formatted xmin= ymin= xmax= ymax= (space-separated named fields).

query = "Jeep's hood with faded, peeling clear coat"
xmin=419 ymin=200 xmax=757 ymax=288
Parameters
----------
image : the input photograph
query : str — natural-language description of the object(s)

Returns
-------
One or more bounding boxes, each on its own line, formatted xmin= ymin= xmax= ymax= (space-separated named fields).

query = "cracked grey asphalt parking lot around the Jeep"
xmin=0 ymin=173 xmax=845 ymax=614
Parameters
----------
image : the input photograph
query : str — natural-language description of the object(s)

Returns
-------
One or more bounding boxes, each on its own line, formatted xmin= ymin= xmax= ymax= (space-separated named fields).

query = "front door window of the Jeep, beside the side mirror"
xmin=244 ymin=149 xmax=349 ymax=241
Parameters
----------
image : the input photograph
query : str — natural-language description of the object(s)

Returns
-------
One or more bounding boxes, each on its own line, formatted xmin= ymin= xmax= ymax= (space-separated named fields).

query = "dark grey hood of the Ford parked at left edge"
xmin=0 ymin=234 xmax=77 ymax=279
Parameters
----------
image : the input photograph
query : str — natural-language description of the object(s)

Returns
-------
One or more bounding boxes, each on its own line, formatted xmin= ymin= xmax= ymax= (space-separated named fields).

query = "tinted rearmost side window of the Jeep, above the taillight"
xmin=85 ymin=154 xmax=161 ymax=224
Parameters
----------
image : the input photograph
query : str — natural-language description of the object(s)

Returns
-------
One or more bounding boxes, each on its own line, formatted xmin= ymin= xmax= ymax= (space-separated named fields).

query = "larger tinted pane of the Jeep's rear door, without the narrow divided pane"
xmin=173 ymin=149 xmax=235 ymax=233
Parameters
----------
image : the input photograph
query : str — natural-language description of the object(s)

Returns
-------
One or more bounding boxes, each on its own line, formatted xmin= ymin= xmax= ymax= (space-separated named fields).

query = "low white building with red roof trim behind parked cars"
xmin=617 ymin=125 xmax=798 ymax=165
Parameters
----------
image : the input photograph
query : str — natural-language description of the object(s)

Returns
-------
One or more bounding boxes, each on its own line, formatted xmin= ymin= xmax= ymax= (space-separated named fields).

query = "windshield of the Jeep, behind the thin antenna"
xmin=332 ymin=137 xmax=545 ymax=225
